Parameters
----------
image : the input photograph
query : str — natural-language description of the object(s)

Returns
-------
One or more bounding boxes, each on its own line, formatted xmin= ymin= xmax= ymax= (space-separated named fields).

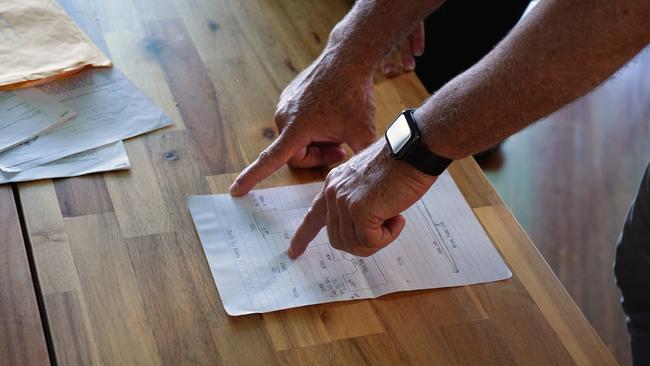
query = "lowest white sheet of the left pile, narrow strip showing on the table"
xmin=0 ymin=141 xmax=131 ymax=184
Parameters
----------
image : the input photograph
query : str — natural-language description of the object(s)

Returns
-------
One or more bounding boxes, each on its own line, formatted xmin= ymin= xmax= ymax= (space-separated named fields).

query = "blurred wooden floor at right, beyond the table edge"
xmin=488 ymin=46 xmax=650 ymax=365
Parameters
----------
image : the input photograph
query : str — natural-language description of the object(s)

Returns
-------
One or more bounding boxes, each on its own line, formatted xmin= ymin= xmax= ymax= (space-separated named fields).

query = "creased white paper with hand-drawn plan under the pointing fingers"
xmin=188 ymin=173 xmax=512 ymax=315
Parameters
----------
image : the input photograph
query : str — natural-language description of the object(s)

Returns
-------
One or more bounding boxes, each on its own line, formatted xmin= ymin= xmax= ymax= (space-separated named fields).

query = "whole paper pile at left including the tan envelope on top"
xmin=0 ymin=0 xmax=172 ymax=184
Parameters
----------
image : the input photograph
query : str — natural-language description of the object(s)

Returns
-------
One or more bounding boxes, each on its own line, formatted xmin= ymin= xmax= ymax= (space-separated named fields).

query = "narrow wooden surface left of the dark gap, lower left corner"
xmin=0 ymin=185 xmax=49 ymax=366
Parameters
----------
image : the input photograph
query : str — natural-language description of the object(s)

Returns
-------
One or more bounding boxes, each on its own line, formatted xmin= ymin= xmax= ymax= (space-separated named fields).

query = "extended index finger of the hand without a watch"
xmin=230 ymin=130 xmax=305 ymax=196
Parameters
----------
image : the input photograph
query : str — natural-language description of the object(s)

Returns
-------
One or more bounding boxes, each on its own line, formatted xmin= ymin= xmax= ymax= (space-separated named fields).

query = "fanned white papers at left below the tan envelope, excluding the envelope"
xmin=0 ymin=69 xmax=172 ymax=184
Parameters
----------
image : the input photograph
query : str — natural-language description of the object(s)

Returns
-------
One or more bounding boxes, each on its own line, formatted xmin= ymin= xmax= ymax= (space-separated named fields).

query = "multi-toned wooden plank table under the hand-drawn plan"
xmin=8 ymin=0 xmax=615 ymax=365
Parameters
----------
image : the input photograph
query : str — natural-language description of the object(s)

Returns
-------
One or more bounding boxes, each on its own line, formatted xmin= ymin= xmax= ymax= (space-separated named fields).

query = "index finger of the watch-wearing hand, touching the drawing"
xmin=287 ymin=190 xmax=327 ymax=258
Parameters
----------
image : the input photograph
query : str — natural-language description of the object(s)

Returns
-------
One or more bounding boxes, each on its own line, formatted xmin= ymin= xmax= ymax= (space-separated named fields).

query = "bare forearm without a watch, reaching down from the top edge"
xmin=321 ymin=0 xmax=444 ymax=75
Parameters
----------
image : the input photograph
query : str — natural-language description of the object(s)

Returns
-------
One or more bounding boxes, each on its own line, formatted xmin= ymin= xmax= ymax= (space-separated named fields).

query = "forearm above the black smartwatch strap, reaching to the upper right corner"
xmin=416 ymin=0 xmax=650 ymax=159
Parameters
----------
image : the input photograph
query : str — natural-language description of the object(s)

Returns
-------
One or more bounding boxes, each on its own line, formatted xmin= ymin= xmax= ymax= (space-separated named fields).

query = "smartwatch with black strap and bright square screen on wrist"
xmin=385 ymin=109 xmax=453 ymax=176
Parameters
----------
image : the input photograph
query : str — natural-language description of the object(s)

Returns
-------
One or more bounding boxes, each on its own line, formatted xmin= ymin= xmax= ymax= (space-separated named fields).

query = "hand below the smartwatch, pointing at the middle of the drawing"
xmin=287 ymin=139 xmax=436 ymax=258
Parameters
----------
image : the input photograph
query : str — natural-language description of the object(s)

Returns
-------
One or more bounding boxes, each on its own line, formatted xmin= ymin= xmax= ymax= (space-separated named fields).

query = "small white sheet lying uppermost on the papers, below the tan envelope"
xmin=0 ymin=89 xmax=75 ymax=151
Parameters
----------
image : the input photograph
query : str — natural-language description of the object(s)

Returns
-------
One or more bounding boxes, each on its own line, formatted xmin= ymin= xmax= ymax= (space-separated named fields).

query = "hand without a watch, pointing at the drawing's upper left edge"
xmin=230 ymin=50 xmax=375 ymax=196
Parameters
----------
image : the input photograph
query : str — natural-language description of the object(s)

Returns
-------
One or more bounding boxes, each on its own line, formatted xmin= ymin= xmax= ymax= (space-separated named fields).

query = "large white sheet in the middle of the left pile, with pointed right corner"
xmin=0 ymin=69 xmax=172 ymax=172
